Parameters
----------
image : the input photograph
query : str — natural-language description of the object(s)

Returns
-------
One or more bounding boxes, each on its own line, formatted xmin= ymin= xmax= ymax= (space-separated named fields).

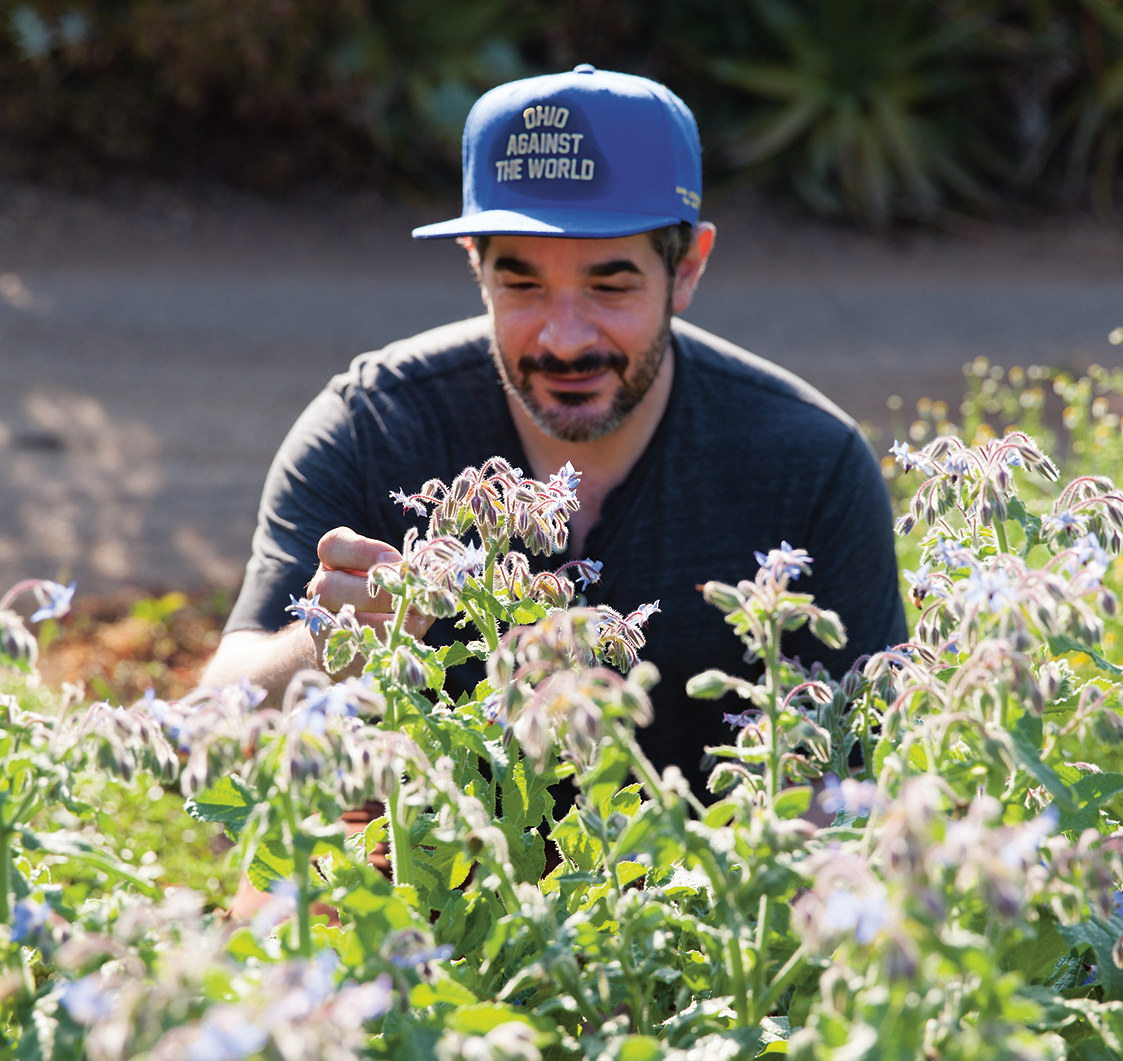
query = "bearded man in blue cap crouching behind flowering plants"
xmin=204 ymin=65 xmax=906 ymax=792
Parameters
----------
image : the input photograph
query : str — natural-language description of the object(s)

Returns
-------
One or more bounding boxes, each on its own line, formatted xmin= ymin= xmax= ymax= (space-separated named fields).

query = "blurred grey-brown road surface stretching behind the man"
xmin=0 ymin=178 xmax=1123 ymax=615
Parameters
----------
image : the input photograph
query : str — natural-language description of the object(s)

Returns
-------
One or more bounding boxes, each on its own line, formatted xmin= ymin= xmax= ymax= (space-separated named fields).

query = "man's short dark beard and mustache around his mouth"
xmin=491 ymin=292 xmax=670 ymax=442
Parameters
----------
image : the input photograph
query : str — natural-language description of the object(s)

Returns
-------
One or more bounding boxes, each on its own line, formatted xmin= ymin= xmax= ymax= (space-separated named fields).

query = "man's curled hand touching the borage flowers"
xmin=308 ymin=527 xmax=432 ymax=655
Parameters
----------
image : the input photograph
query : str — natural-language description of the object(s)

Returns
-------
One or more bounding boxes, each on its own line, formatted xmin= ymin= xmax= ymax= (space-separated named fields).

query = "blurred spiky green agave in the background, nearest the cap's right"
xmin=710 ymin=0 xmax=986 ymax=227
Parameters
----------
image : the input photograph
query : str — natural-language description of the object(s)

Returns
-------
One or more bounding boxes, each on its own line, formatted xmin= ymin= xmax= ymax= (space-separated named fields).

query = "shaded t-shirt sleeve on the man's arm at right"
xmin=784 ymin=429 xmax=909 ymax=678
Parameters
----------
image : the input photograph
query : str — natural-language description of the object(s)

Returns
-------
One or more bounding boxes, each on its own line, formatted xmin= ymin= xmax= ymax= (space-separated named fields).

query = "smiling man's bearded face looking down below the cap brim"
xmin=480 ymin=234 xmax=673 ymax=442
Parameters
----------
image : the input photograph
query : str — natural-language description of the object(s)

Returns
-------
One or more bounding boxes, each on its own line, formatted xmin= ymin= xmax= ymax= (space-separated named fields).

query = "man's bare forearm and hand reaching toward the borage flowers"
xmin=200 ymin=527 xmax=431 ymax=705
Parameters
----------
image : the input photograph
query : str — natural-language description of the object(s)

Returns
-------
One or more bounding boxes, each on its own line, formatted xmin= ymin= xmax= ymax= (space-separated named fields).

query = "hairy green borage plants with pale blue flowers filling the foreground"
xmin=8 ymin=436 xmax=1123 ymax=1061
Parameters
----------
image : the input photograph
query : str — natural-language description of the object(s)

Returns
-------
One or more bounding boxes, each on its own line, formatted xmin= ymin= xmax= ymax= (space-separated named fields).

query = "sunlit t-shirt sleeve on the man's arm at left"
xmin=226 ymin=386 xmax=367 ymax=633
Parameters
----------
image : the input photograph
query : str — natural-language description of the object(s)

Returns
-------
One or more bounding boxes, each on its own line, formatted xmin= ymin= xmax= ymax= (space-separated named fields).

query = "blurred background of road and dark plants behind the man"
xmin=0 ymin=0 xmax=1123 ymax=688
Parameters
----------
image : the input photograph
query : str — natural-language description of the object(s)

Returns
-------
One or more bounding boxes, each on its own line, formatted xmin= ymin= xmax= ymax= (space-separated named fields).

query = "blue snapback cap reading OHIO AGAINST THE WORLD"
xmin=413 ymin=63 xmax=702 ymax=239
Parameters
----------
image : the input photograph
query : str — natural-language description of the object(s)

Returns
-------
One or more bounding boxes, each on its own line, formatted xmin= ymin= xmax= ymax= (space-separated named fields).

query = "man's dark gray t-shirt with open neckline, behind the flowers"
xmin=226 ymin=317 xmax=906 ymax=792
